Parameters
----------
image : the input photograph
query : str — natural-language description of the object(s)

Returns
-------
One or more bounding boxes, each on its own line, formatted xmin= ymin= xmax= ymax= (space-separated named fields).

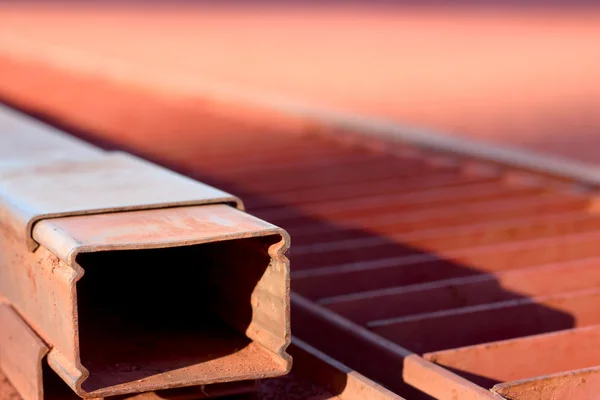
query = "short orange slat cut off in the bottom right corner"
xmin=492 ymin=367 xmax=600 ymax=400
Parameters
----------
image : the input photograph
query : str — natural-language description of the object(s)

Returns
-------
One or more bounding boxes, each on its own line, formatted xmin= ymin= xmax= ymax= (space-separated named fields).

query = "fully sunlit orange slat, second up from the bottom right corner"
xmin=423 ymin=325 xmax=600 ymax=388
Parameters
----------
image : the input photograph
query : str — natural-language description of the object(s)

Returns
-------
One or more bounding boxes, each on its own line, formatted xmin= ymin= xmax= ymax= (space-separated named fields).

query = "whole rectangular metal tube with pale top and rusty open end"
xmin=0 ymin=104 xmax=291 ymax=398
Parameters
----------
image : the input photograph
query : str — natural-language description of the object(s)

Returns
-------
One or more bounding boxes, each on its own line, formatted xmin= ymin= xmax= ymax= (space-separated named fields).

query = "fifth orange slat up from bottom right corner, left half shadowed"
xmin=292 ymin=233 xmax=600 ymax=298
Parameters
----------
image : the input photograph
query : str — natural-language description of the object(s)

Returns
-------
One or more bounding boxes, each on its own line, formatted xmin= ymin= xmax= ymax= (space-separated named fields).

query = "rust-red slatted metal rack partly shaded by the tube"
xmin=5 ymin=60 xmax=600 ymax=399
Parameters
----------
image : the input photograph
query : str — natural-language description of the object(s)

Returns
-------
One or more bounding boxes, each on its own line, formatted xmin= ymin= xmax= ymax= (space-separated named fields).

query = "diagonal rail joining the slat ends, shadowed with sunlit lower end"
xmin=292 ymin=293 xmax=499 ymax=400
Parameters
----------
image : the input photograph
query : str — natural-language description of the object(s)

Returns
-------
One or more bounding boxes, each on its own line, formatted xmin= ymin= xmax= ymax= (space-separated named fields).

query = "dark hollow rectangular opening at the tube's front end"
xmin=77 ymin=236 xmax=285 ymax=393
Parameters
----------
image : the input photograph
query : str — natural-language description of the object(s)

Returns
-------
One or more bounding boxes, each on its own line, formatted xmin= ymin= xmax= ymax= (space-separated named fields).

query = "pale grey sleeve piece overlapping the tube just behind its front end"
xmin=0 ymin=153 xmax=242 ymax=250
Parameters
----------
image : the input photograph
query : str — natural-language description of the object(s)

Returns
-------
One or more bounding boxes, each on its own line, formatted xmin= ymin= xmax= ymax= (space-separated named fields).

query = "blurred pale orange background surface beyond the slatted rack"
xmin=0 ymin=2 xmax=600 ymax=162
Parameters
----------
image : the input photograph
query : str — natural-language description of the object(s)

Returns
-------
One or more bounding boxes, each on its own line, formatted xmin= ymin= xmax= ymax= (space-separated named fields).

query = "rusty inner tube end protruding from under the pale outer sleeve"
xmin=0 ymin=205 xmax=291 ymax=397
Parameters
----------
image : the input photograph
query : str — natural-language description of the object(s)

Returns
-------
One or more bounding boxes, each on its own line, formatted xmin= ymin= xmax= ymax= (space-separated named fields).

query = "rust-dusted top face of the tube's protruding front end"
xmin=33 ymin=204 xmax=289 ymax=265
